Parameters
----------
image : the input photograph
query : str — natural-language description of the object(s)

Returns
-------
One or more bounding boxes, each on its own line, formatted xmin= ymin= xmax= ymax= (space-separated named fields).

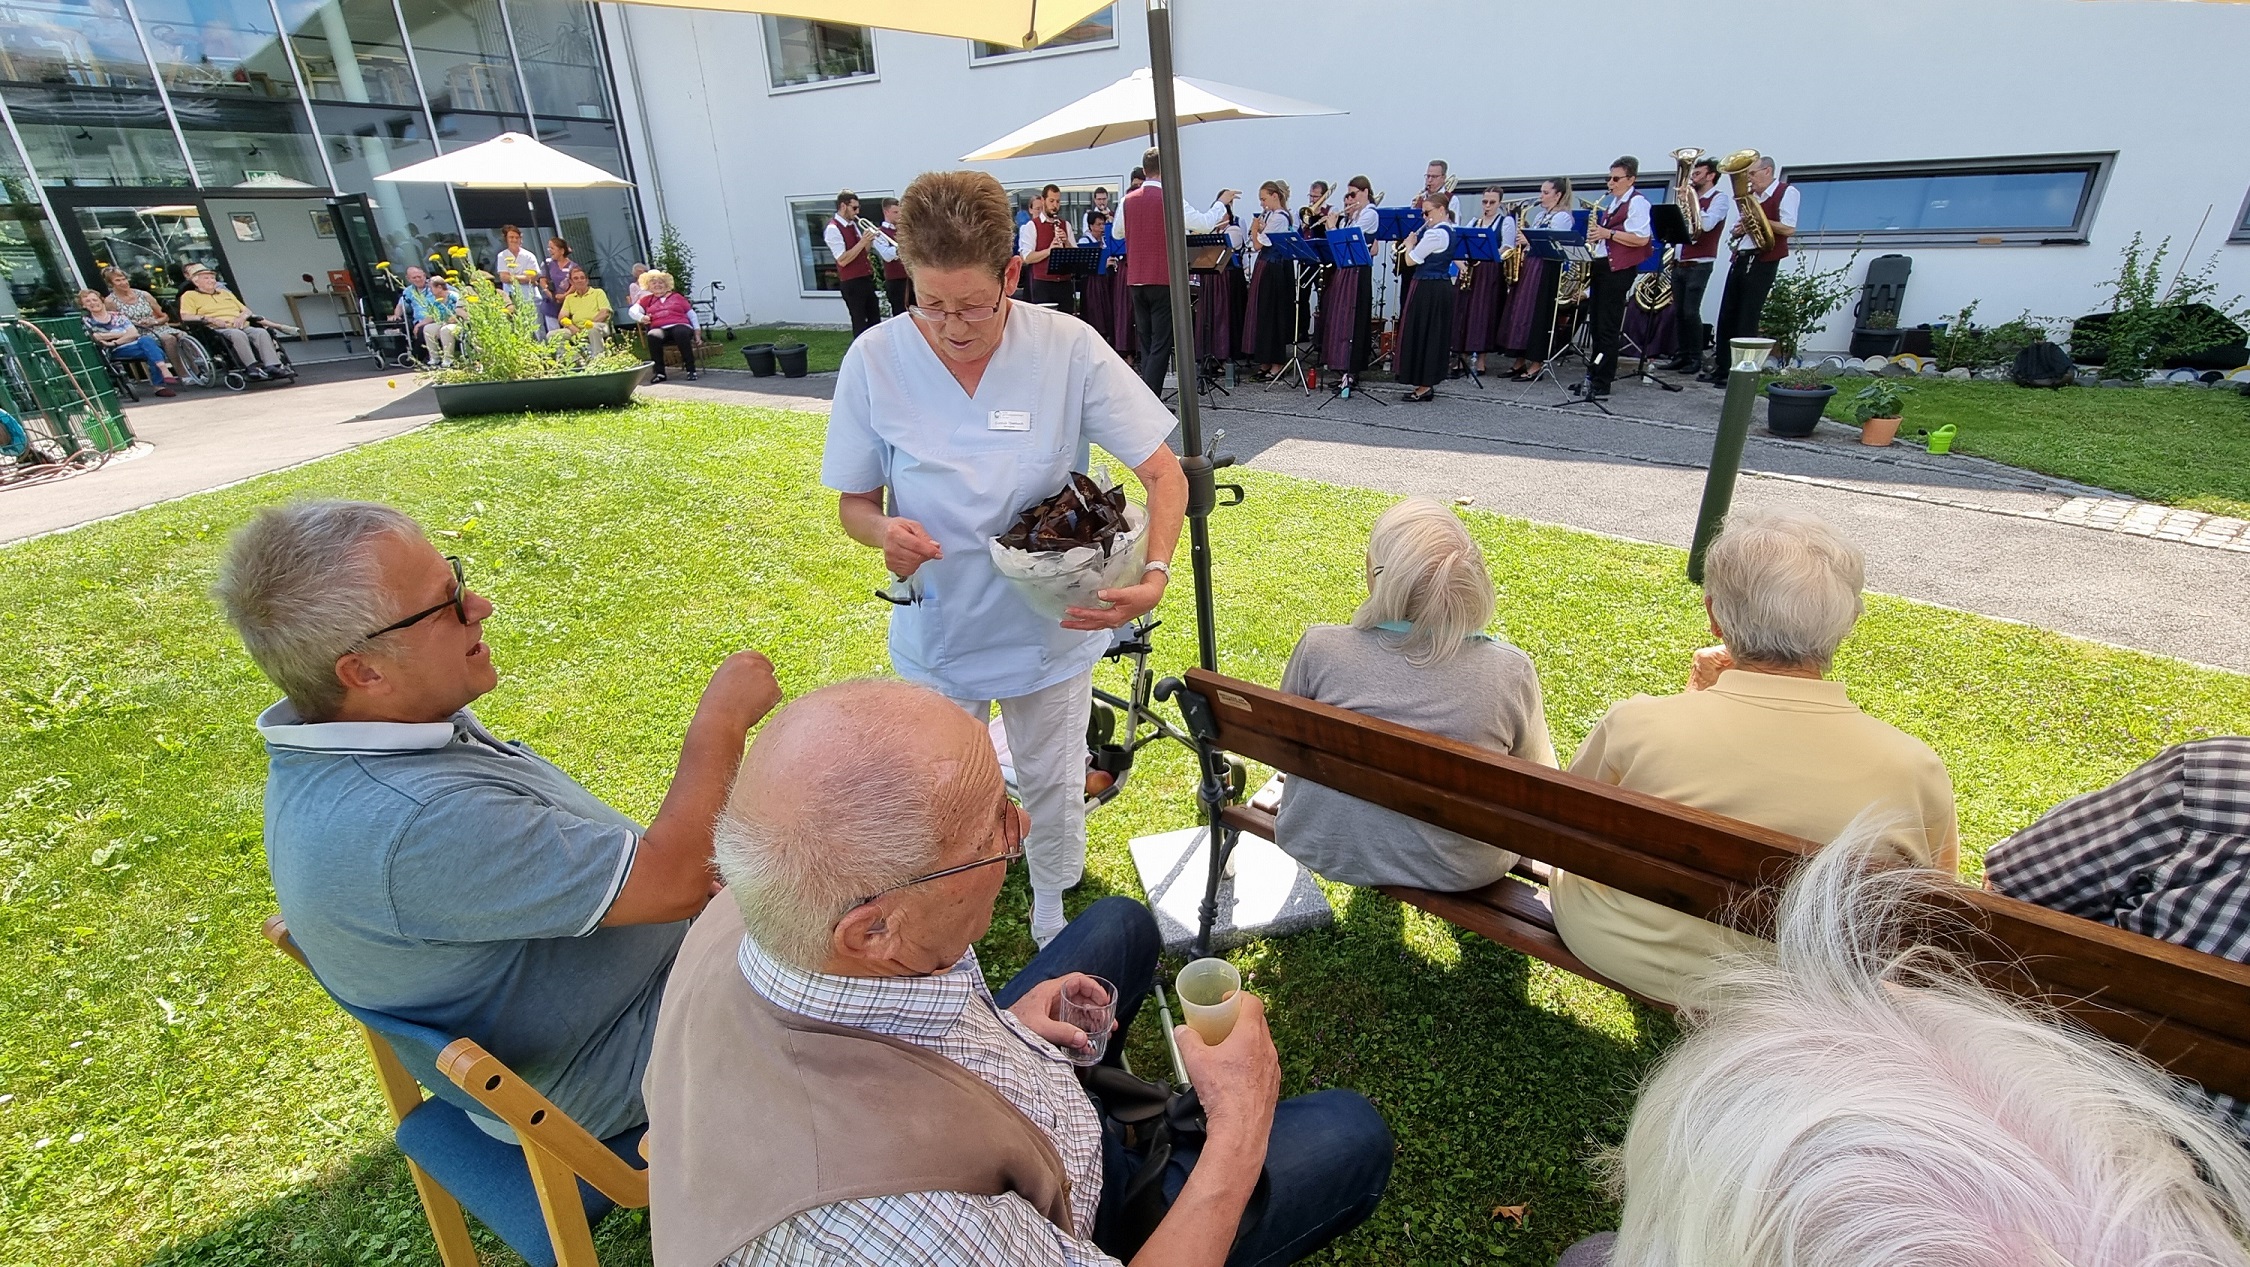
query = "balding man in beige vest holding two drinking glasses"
xmin=646 ymin=682 xmax=1391 ymax=1267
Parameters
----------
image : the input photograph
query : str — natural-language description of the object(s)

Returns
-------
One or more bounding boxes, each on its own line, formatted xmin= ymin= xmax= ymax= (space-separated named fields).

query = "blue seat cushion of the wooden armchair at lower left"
xmin=398 ymin=1098 xmax=648 ymax=1267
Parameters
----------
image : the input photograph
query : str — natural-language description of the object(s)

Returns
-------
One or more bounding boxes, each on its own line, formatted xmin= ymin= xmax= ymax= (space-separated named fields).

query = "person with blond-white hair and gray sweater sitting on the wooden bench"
xmin=1274 ymin=497 xmax=1555 ymax=891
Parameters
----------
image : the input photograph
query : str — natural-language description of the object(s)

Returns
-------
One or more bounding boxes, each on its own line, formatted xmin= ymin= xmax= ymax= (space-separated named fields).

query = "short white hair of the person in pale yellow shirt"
xmin=1703 ymin=513 xmax=1868 ymax=673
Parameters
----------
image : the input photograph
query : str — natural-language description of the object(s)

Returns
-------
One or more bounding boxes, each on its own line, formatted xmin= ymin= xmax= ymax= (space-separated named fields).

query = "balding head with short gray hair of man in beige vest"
xmin=713 ymin=677 xmax=999 ymax=972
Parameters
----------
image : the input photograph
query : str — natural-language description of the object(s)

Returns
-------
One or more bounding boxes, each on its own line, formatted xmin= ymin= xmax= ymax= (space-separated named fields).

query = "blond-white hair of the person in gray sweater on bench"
xmin=1352 ymin=497 xmax=1496 ymax=668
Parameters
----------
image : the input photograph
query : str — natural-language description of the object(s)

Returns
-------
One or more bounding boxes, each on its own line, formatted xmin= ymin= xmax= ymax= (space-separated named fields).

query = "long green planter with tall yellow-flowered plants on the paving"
xmin=409 ymin=248 xmax=650 ymax=419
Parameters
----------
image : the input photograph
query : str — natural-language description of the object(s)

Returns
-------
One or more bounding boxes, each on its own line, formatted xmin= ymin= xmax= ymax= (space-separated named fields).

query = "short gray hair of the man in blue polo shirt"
xmin=212 ymin=502 xmax=423 ymax=722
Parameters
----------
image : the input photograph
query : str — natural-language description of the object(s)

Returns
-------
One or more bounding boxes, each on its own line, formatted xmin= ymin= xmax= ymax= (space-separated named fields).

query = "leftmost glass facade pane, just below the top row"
xmin=5 ymin=88 xmax=189 ymax=185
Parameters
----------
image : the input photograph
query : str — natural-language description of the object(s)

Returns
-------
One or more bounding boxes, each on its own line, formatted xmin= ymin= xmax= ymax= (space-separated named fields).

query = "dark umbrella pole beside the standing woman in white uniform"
xmin=1148 ymin=0 xmax=1240 ymax=954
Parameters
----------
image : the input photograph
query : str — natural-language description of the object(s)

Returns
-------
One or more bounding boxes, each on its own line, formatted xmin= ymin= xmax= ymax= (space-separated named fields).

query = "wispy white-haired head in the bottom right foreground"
xmin=1562 ymin=828 xmax=2250 ymax=1267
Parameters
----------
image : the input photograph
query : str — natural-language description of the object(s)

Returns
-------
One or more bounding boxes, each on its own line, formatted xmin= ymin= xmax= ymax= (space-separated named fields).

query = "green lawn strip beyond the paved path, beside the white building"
xmin=1827 ymin=378 xmax=2250 ymax=518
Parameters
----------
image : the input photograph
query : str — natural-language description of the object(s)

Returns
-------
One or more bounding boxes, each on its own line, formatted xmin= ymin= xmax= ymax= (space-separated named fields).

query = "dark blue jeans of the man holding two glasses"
xmin=997 ymin=898 xmax=1391 ymax=1267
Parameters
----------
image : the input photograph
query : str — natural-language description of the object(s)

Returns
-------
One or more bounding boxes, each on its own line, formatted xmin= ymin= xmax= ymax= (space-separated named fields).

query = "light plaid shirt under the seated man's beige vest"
xmin=720 ymin=936 xmax=1116 ymax=1267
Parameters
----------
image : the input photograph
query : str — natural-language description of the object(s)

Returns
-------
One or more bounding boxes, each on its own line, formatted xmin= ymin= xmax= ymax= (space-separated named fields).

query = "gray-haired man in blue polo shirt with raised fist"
xmin=216 ymin=502 xmax=779 ymax=1136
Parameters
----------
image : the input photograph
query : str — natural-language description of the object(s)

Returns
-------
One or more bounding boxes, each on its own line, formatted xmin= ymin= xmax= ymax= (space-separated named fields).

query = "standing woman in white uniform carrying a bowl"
xmin=821 ymin=171 xmax=1188 ymax=947
